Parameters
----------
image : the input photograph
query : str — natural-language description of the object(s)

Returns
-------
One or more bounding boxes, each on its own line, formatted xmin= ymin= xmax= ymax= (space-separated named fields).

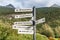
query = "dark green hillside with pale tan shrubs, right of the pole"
xmin=37 ymin=7 xmax=60 ymax=37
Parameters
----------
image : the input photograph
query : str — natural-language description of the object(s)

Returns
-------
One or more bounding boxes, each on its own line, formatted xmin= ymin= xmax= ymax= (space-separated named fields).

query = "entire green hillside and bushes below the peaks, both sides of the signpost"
xmin=0 ymin=7 xmax=60 ymax=40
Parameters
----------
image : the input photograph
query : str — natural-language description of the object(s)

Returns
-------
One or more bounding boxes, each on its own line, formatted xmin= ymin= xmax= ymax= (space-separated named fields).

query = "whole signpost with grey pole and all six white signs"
xmin=12 ymin=7 xmax=45 ymax=40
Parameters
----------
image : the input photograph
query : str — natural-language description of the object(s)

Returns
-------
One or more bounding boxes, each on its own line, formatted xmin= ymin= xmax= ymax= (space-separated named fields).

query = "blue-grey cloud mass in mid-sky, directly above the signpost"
xmin=17 ymin=0 xmax=48 ymax=7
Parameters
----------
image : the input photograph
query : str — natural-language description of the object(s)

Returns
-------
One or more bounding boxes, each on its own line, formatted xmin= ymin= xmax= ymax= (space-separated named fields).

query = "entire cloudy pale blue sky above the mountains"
xmin=0 ymin=0 xmax=60 ymax=8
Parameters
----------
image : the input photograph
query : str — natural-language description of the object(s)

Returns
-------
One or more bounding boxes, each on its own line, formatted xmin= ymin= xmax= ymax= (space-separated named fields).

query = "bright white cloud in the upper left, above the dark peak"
xmin=0 ymin=0 xmax=22 ymax=8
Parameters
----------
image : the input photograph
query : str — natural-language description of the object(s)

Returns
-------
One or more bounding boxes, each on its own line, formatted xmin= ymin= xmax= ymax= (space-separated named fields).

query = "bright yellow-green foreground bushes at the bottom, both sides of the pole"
xmin=0 ymin=20 xmax=48 ymax=40
